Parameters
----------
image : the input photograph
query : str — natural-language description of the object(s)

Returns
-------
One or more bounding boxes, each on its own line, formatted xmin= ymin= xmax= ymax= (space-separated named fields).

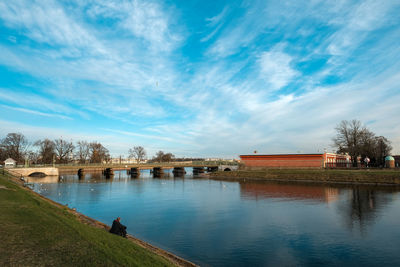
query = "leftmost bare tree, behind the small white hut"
xmin=1 ymin=133 xmax=29 ymax=164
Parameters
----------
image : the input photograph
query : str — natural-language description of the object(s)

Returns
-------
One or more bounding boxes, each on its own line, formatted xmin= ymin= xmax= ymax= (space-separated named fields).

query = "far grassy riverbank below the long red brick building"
xmin=210 ymin=169 xmax=400 ymax=186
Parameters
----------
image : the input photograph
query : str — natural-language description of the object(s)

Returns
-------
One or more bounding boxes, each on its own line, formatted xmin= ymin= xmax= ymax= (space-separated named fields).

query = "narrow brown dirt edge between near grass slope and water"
xmin=4 ymin=172 xmax=199 ymax=267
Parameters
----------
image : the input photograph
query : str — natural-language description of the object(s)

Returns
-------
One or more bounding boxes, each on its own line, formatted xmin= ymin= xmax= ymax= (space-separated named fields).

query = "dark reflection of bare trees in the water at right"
xmin=339 ymin=186 xmax=392 ymax=232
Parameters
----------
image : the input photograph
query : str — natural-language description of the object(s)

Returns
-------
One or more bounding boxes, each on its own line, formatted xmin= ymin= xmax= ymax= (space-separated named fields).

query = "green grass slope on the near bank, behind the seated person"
xmin=0 ymin=174 xmax=173 ymax=266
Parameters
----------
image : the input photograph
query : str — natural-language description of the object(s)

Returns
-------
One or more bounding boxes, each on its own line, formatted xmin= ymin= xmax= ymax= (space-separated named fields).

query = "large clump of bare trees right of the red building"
xmin=333 ymin=120 xmax=392 ymax=167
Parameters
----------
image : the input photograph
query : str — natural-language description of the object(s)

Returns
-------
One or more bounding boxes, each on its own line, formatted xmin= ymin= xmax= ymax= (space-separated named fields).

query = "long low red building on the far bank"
xmin=240 ymin=153 xmax=351 ymax=169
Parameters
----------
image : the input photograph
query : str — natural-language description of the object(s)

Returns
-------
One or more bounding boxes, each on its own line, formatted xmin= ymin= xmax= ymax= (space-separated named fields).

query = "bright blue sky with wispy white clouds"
xmin=0 ymin=0 xmax=400 ymax=158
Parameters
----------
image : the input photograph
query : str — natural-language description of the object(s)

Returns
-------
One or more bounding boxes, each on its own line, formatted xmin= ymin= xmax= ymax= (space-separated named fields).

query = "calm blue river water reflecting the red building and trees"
xmin=31 ymin=169 xmax=400 ymax=266
